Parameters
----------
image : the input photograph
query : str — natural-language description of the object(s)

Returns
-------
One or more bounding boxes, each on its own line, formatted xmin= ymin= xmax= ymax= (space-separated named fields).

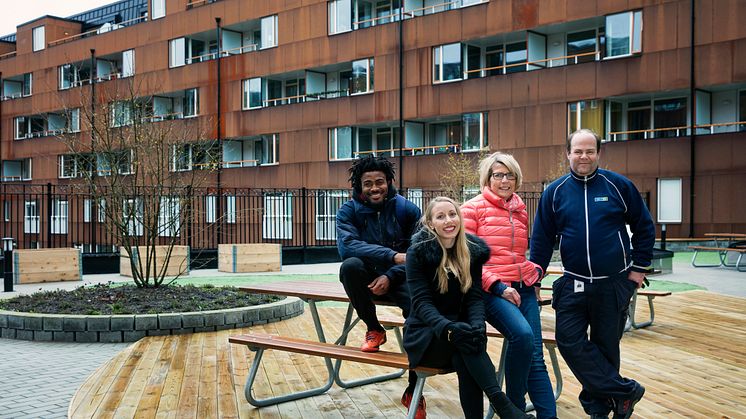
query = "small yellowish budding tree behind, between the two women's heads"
xmin=440 ymin=149 xmax=489 ymax=202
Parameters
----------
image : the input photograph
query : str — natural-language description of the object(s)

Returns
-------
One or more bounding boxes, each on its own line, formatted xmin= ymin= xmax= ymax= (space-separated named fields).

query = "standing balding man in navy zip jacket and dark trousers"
xmin=531 ymin=129 xmax=655 ymax=418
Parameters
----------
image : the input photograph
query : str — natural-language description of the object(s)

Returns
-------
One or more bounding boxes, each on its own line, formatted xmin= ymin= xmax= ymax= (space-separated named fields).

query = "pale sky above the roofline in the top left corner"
xmin=0 ymin=0 xmax=117 ymax=36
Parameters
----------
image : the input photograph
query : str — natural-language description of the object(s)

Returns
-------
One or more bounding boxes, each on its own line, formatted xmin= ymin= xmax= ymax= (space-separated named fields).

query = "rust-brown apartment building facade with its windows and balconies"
xmin=0 ymin=0 xmax=746 ymax=246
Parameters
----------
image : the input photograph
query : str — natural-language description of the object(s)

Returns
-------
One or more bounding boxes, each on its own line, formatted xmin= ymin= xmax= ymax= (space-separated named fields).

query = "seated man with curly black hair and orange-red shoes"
xmin=337 ymin=156 xmax=425 ymax=417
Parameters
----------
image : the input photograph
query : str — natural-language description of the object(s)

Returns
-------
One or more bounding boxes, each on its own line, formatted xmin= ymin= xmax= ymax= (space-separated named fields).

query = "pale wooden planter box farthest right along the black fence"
xmin=218 ymin=243 xmax=282 ymax=273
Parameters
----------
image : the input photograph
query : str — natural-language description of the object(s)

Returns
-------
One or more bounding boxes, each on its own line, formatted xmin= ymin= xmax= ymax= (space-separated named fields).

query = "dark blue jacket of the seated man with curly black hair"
xmin=337 ymin=189 xmax=421 ymax=284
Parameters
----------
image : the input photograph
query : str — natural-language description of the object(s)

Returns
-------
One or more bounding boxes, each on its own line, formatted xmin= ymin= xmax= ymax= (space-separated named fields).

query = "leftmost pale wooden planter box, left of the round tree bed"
xmin=13 ymin=248 xmax=83 ymax=284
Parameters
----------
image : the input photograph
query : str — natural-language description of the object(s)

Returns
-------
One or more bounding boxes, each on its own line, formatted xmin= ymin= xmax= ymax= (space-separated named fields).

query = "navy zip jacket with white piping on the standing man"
xmin=530 ymin=169 xmax=655 ymax=281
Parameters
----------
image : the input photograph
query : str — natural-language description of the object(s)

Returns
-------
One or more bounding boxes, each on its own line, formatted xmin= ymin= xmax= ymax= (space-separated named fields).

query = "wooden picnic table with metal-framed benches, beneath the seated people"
xmin=235 ymin=280 xmax=562 ymax=417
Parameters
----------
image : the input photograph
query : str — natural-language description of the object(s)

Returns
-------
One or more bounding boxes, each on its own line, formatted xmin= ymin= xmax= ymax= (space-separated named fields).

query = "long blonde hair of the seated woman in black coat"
xmin=420 ymin=196 xmax=472 ymax=294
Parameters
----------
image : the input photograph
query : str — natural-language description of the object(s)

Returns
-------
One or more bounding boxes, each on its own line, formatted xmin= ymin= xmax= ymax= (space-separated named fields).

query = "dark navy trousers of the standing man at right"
xmin=552 ymin=272 xmax=637 ymax=414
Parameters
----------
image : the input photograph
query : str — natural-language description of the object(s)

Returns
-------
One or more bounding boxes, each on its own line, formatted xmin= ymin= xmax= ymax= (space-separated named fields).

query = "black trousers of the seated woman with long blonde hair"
xmin=420 ymin=337 xmax=501 ymax=419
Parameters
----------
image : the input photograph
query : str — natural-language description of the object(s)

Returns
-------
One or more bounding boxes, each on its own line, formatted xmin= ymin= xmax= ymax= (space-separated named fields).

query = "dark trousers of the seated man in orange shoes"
xmin=339 ymin=258 xmax=411 ymax=330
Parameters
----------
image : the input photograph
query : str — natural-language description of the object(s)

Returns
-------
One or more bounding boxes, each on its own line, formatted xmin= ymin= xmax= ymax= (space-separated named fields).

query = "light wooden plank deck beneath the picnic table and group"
xmin=69 ymin=291 xmax=746 ymax=419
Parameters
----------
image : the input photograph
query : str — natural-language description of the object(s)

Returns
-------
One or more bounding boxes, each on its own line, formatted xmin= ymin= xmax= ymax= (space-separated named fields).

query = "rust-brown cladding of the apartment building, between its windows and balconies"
xmin=0 ymin=0 xmax=746 ymax=237
